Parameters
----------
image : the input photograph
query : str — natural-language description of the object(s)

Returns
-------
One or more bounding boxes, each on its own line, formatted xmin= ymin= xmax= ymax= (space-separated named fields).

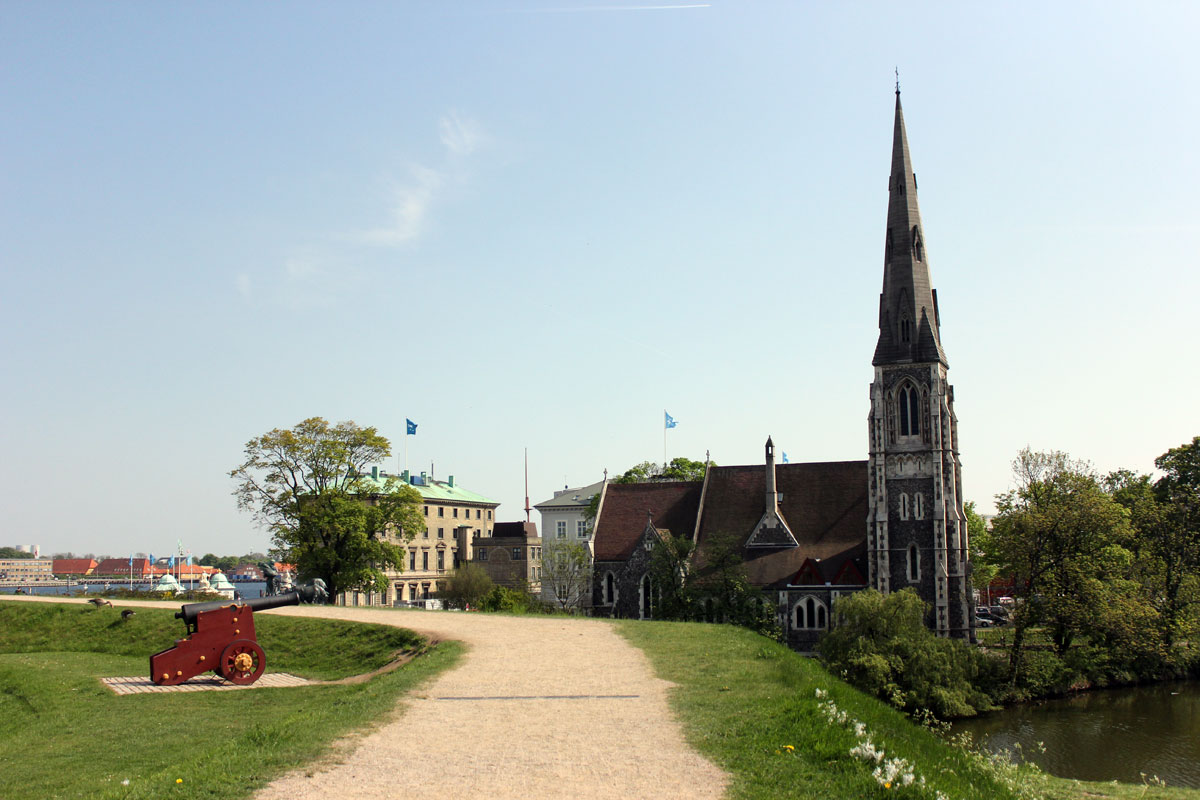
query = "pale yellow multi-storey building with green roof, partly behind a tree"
xmin=337 ymin=468 xmax=500 ymax=606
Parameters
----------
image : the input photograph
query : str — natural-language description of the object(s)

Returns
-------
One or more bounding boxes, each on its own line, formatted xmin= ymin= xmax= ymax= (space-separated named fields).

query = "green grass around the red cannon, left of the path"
xmin=0 ymin=602 xmax=461 ymax=800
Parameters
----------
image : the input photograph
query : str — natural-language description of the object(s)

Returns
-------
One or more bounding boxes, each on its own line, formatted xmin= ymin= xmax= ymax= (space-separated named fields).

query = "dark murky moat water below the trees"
xmin=953 ymin=681 xmax=1200 ymax=788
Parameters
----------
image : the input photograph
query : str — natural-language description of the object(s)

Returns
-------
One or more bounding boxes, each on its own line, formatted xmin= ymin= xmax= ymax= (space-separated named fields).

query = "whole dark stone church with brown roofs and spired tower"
xmin=592 ymin=88 xmax=974 ymax=651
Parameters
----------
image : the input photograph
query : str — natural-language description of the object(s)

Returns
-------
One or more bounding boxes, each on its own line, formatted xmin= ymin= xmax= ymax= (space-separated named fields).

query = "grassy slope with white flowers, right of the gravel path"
xmin=618 ymin=622 xmax=1200 ymax=800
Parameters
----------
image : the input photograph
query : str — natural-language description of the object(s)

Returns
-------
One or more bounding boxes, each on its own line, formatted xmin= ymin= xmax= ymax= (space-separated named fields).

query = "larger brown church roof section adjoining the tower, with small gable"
xmin=691 ymin=461 xmax=868 ymax=588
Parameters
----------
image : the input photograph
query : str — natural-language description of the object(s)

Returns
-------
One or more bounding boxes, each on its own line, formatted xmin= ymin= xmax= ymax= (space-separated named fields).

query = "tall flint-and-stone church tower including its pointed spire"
xmin=868 ymin=85 xmax=974 ymax=638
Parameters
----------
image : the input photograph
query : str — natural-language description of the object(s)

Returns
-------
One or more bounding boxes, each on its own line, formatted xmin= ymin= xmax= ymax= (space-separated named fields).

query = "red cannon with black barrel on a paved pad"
xmin=150 ymin=591 xmax=301 ymax=686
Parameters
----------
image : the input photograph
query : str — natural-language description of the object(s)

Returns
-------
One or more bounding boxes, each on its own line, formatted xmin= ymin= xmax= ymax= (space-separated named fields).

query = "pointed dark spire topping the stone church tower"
xmin=871 ymin=85 xmax=947 ymax=366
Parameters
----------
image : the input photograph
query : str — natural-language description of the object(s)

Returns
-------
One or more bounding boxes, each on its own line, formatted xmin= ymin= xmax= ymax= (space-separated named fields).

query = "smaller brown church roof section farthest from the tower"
xmin=592 ymin=481 xmax=700 ymax=561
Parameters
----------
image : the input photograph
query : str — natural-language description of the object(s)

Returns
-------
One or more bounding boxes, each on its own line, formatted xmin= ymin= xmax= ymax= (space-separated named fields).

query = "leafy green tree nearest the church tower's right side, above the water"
xmin=989 ymin=447 xmax=1127 ymax=685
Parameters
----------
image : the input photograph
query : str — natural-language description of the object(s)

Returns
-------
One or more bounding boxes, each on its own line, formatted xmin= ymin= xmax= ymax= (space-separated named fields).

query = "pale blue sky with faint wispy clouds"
xmin=0 ymin=0 xmax=1200 ymax=555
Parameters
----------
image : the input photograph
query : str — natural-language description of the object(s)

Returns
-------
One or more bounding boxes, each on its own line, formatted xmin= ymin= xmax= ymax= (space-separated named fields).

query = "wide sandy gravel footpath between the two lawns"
xmin=256 ymin=607 xmax=726 ymax=800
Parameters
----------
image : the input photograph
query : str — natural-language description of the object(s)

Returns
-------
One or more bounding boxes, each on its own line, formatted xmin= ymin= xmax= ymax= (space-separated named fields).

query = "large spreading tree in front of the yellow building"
xmin=229 ymin=417 xmax=425 ymax=600
